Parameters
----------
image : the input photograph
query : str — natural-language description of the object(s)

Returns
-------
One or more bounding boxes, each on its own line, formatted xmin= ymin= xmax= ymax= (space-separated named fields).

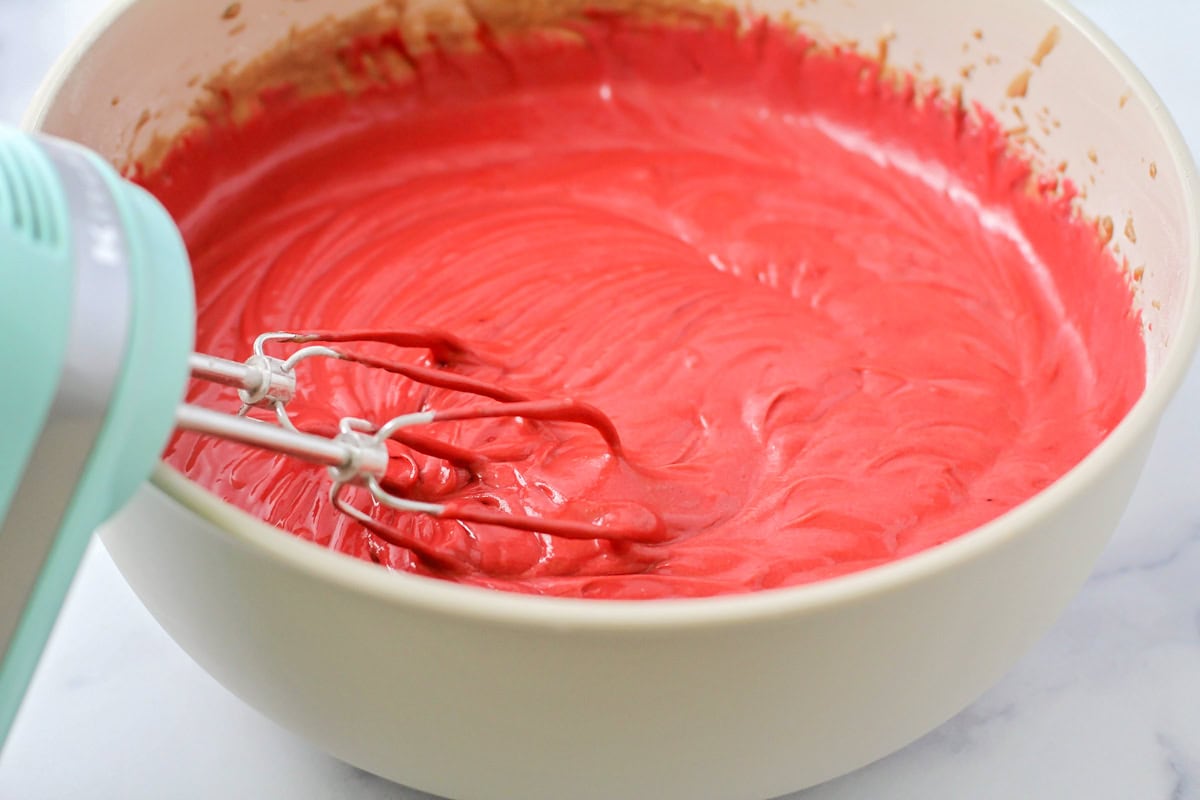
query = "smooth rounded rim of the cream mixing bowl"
xmin=23 ymin=0 xmax=1200 ymax=631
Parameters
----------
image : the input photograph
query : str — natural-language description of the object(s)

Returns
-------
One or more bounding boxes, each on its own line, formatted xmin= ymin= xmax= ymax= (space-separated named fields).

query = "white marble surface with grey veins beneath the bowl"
xmin=0 ymin=0 xmax=1200 ymax=800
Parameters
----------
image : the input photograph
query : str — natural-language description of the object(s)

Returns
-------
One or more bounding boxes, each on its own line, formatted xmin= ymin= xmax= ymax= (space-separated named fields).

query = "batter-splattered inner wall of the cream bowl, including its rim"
xmin=29 ymin=0 xmax=1200 ymax=619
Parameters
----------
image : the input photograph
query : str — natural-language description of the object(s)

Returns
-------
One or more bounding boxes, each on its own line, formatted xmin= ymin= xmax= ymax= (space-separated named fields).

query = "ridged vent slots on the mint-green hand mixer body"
xmin=0 ymin=134 xmax=60 ymax=247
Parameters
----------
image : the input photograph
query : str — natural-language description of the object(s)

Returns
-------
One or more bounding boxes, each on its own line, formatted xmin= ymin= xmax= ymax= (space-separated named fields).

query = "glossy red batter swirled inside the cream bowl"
xmin=145 ymin=18 xmax=1145 ymax=599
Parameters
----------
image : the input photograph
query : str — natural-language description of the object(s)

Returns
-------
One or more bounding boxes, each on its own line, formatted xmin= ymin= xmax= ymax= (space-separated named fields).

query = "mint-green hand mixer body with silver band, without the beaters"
xmin=0 ymin=127 xmax=194 ymax=746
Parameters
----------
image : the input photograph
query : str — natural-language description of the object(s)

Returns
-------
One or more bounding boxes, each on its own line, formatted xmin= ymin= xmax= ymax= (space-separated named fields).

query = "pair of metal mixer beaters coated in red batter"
xmin=182 ymin=331 xmax=661 ymax=548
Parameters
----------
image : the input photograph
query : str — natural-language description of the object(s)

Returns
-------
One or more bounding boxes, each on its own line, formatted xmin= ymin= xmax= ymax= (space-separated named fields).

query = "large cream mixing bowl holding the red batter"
xmin=21 ymin=0 xmax=1200 ymax=800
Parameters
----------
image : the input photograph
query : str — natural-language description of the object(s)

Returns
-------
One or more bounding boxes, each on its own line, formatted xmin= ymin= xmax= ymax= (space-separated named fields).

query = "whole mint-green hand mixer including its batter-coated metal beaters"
xmin=0 ymin=127 xmax=661 ymax=745
